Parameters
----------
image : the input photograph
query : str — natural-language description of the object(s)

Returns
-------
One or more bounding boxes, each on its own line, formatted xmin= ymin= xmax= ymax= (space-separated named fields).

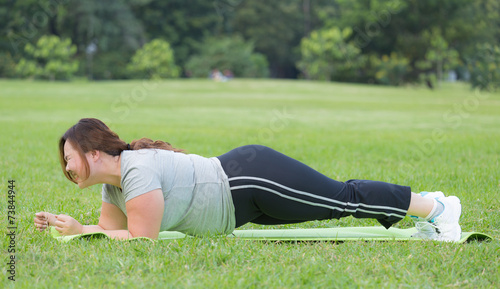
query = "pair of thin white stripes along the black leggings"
xmin=229 ymin=176 xmax=407 ymax=218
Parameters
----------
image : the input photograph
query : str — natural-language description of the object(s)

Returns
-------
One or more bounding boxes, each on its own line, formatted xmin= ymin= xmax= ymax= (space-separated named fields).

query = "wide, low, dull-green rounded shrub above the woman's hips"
xmin=185 ymin=36 xmax=269 ymax=78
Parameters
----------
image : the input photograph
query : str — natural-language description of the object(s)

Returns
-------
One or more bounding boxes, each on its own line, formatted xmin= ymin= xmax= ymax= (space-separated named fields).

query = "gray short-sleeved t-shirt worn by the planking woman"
xmin=102 ymin=149 xmax=236 ymax=235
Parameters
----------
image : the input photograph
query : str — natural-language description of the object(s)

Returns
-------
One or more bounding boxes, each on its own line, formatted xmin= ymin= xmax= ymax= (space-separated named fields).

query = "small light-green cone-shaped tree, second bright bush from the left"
xmin=127 ymin=39 xmax=179 ymax=79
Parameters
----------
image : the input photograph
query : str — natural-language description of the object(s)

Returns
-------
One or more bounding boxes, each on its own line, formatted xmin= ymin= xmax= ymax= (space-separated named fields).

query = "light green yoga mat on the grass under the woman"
xmin=51 ymin=226 xmax=493 ymax=243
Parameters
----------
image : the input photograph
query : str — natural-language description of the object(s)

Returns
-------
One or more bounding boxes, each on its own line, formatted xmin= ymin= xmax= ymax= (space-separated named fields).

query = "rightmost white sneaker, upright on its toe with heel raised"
xmin=431 ymin=196 xmax=462 ymax=242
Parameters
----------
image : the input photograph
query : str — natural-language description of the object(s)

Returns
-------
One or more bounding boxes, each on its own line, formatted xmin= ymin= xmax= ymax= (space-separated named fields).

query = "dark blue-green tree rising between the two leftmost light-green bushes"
xmin=59 ymin=0 xmax=146 ymax=79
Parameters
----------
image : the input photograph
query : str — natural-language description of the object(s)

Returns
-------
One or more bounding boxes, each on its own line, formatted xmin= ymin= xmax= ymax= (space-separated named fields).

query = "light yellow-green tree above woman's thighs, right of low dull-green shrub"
xmin=297 ymin=27 xmax=362 ymax=81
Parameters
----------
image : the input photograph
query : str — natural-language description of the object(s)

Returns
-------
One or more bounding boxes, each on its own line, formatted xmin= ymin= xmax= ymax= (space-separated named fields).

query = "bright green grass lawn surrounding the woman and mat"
xmin=0 ymin=80 xmax=500 ymax=288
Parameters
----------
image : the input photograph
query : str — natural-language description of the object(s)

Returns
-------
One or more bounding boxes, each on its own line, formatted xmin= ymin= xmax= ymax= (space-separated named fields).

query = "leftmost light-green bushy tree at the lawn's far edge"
xmin=16 ymin=36 xmax=78 ymax=80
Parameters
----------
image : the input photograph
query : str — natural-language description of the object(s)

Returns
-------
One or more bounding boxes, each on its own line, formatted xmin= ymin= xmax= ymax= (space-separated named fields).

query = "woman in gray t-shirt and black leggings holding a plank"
xmin=34 ymin=118 xmax=461 ymax=241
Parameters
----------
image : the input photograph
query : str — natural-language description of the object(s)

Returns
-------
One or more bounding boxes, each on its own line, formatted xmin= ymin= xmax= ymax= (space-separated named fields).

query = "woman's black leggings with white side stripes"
xmin=218 ymin=145 xmax=411 ymax=228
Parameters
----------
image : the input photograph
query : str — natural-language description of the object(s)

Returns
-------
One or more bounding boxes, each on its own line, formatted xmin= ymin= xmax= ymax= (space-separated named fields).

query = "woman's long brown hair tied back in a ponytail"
xmin=59 ymin=118 xmax=183 ymax=183
